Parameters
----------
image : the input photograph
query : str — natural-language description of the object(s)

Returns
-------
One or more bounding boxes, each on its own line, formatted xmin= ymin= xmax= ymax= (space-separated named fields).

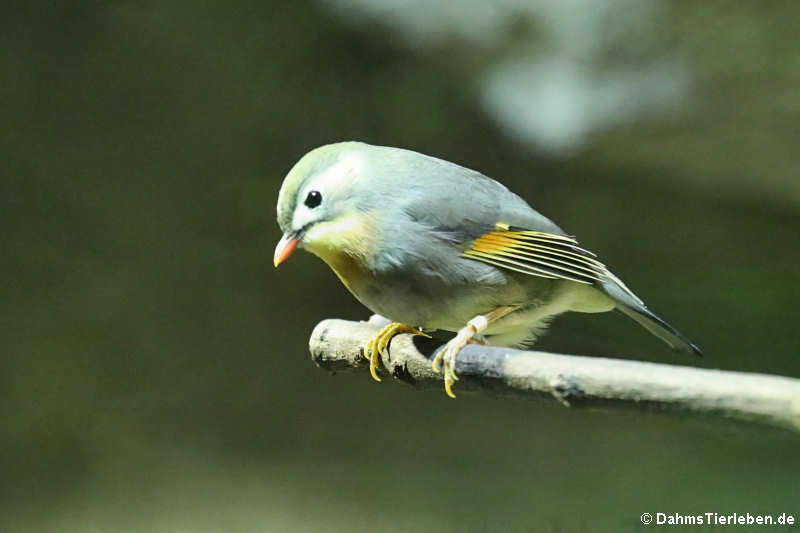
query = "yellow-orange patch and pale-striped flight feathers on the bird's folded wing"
xmin=461 ymin=223 xmax=607 ymax=284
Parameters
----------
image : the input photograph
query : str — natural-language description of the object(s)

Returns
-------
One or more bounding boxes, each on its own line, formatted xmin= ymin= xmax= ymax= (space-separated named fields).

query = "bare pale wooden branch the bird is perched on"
xmin=309 ymin=319 xmax=800 ymax=431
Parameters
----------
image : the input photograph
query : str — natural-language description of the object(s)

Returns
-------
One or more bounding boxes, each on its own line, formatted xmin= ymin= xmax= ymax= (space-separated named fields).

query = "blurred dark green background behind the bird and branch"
xmin=0 ymin=0 xmax=800 ymax=532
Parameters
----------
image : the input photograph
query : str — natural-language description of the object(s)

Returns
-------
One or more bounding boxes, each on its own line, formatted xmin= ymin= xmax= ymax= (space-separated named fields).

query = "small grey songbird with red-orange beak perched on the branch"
xmin=274 ymin=142 xmax=700 ymax=397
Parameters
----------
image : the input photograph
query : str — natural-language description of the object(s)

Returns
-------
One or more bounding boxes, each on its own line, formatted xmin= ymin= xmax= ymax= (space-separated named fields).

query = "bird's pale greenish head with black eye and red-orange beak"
xmin=274 ymin=142 xmax=367 ymax=267
